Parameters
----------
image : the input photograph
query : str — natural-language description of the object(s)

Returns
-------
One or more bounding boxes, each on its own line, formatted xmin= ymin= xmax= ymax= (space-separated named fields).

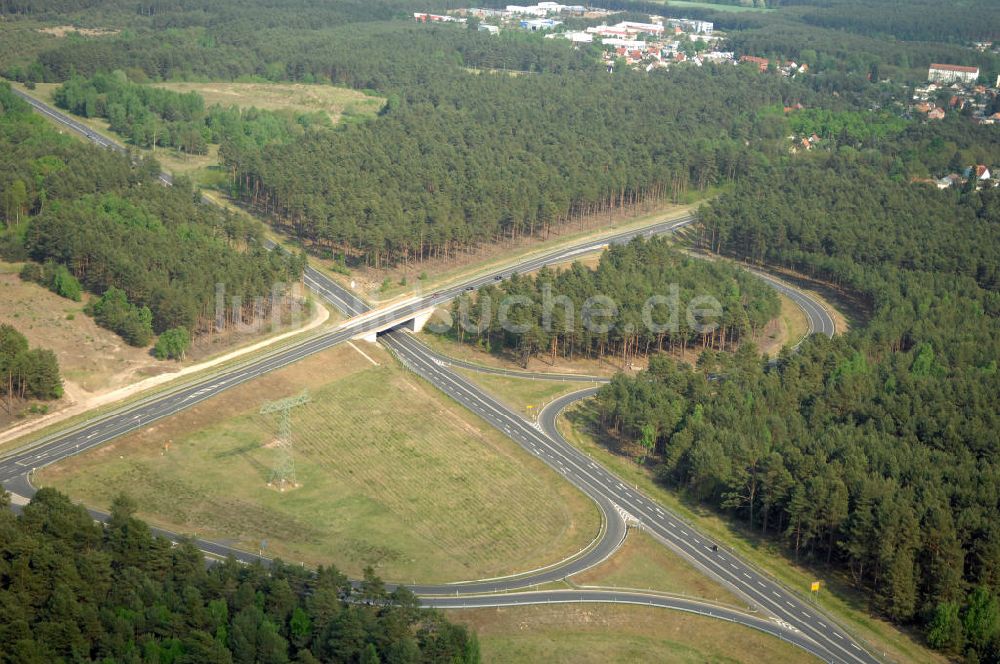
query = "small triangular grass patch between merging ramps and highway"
xmin=571 ymin=528 xmax=746 ymax=609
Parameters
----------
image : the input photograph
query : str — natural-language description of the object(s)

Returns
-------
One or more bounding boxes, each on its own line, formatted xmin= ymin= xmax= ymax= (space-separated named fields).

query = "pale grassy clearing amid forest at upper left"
xmin=154 ymin=82 xmax=385 ymax=123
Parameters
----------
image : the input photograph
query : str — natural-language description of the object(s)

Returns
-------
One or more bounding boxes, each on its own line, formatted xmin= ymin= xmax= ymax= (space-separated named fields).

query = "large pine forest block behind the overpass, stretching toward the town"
xmin=227 ymin=62 xmax=801 ymax=267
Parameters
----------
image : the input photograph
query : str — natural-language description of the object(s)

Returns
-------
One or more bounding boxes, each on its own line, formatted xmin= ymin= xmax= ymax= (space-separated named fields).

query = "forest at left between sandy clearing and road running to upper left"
xmin=0 ymin=86 xmax=304 ymax=345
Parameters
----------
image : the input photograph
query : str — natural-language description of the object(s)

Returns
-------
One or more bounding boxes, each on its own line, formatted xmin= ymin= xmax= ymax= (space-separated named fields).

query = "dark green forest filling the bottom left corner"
xmin=0 ymin=489 xmax=479 ymax=664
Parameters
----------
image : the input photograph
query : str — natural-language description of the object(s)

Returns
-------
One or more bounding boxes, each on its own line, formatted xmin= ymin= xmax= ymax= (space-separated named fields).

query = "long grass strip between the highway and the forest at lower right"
xmin=559 ymin=402 xmax=947 ymax=663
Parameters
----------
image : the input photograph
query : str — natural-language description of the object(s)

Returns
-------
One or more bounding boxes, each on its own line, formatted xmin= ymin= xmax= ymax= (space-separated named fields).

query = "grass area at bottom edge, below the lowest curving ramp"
xmin=446 ymin=604 xmax=819 ymax=664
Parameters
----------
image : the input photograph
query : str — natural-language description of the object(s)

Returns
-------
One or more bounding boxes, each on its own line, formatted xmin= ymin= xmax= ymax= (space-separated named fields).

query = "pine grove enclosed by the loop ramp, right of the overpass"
xmin=445 ymin=238 xmax=780 ymax=366
